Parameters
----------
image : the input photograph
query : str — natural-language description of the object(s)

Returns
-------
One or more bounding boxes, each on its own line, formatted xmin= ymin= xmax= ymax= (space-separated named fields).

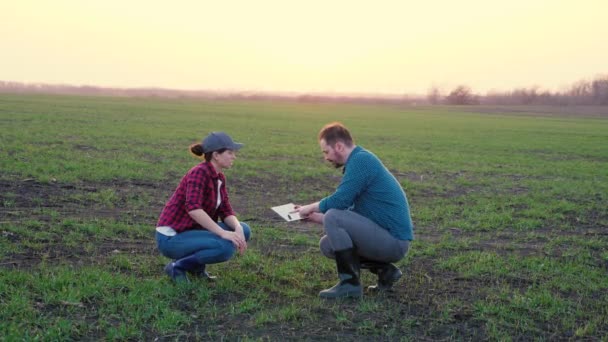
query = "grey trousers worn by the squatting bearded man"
xmin=319 ymin=209 xmax=410 ymax=262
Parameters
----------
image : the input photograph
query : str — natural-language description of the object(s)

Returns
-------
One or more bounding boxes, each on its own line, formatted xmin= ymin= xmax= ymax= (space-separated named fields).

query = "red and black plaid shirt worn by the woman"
xmin=156 ymin=162 xmax=234 ymax=233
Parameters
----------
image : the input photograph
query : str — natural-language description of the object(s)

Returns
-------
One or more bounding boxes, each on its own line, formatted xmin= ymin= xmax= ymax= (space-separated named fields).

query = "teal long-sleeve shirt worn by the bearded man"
xmin=319 ymin=146 xmax=414 ymax=240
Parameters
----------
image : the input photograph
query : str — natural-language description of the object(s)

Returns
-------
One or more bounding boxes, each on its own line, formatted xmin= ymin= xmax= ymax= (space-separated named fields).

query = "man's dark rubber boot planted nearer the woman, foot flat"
xmin=319 ymin=248 xmax=363 ymax=299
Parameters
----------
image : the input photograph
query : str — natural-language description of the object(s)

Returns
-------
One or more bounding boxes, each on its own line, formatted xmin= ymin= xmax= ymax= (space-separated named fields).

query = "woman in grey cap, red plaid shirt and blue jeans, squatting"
xmin=156 ymin=132 xmax=251 ymax=281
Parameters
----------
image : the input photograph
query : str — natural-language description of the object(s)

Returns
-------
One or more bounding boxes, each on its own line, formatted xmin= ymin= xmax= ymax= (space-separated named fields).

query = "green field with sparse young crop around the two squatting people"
xmin=0 ymin=94 xmax=608 ymax=340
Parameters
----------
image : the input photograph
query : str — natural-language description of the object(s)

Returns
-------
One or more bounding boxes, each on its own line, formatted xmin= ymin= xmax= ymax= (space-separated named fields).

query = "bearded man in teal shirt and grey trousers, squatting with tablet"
xmin=296 ymin=122 xmax=414 ymax=298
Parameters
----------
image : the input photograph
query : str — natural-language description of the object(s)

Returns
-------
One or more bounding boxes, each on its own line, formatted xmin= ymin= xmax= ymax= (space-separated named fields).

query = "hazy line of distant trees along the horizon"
xmin=0 ymin=75 xmax=608 ymax=106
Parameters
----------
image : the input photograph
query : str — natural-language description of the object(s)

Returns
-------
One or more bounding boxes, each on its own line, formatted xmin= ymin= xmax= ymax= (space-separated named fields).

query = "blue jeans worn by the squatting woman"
xmin=156 ymin=222 xmax=251 ymax=264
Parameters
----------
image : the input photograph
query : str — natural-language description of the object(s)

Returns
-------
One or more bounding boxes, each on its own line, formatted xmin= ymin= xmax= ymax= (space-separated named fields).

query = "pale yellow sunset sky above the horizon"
xmin=0 ymin=0 xmax=608 ymax=94
